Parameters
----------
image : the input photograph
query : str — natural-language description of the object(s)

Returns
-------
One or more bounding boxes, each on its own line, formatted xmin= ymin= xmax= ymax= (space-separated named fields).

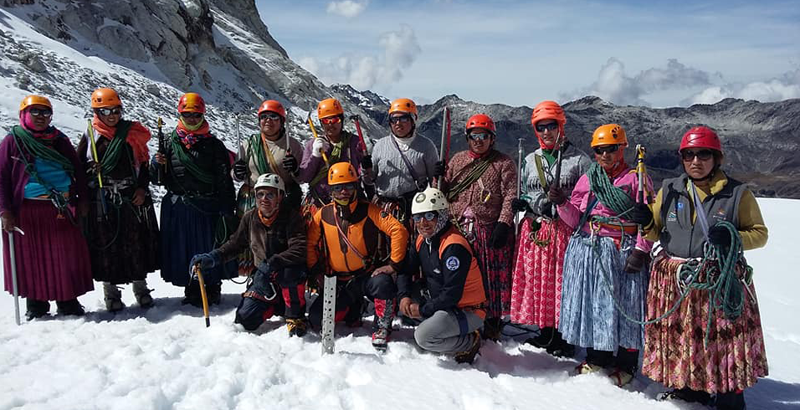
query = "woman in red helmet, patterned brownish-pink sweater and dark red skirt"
xmin=437 ymin=114 xmax=517 ymax=340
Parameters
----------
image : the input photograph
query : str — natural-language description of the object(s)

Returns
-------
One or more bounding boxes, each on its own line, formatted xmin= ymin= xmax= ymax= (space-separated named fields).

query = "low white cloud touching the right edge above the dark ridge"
xmin=683 ymin=68 xmax=800 ymax=105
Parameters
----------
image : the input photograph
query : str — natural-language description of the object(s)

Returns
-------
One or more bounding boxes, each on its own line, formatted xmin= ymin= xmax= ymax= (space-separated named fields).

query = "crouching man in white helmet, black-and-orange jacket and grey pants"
xmin=397 ymin=188 xmax=486 ymax=363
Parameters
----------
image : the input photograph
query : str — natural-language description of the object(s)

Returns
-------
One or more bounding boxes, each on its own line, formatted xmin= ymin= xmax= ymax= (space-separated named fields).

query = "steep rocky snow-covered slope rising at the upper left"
xmin=0 ymin=0 xmax=382 ymax=153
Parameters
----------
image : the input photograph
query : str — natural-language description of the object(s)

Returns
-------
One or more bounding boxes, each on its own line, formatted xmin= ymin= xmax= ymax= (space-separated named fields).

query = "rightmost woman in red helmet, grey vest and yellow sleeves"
xmin=637 ymin=126 xmax=767 ymax=409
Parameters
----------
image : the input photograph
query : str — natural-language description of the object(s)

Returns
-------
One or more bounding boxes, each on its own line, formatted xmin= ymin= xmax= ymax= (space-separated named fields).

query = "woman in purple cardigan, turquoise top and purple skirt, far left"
xmin=0 ymin=95 xmax=94 ymax=320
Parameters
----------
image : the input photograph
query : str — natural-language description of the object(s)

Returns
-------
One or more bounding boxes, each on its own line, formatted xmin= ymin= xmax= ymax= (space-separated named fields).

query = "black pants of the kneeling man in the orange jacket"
xmin=308 ymin=274 xmax=397 ymax=329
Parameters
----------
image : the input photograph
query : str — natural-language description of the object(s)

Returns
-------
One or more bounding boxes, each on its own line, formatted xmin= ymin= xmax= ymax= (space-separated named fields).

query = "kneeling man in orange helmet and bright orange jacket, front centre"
xmin=307 ymin=162 xmax=408 ymax=349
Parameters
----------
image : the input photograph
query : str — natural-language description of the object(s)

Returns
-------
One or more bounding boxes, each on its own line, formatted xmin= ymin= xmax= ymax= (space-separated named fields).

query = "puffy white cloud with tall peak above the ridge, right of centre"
xmin=561 ymin=57 xmax=719 ymax=106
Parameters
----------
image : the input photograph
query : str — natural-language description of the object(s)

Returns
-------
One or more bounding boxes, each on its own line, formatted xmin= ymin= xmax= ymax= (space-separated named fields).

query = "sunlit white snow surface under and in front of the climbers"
xmin=0 ymin=200 xmax=800 ymax=410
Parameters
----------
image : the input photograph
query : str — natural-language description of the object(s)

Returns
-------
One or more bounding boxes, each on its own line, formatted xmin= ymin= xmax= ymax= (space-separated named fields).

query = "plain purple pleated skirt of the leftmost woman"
xmin=3 ymin=199 xmax=94 ymax=300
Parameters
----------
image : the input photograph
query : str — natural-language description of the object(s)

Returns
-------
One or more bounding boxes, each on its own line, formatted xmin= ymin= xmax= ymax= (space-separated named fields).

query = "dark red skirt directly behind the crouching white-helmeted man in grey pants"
xmin=476 ymin=223 xmax=514 ymax=318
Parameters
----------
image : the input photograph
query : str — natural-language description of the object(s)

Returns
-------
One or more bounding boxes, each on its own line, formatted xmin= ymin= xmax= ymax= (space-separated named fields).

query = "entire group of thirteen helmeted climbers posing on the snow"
xmin=0 ymin=88 xmax=767 ymax=409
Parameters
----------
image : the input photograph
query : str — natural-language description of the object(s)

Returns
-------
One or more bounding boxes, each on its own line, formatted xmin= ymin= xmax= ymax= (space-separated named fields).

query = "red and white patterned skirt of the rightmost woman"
xmin=642 ymin=257 xmax=769 ymax=394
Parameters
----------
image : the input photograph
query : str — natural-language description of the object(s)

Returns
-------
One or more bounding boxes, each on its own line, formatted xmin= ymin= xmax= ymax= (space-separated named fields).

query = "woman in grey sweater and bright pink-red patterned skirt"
xmin=511 ymin=101 xmax=591 ymax=357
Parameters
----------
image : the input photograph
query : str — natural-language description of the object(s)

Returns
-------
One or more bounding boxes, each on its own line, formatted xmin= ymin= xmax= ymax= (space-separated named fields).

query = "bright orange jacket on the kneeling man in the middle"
xmin=306 ymin=201 xmax=408 ymax=273
